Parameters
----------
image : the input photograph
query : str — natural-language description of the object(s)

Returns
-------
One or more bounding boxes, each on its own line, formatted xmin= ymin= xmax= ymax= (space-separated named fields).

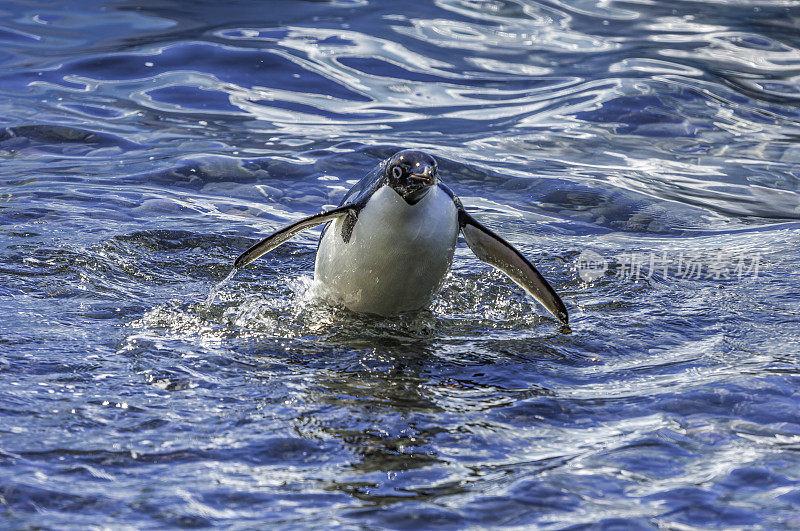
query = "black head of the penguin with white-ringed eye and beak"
xmin=383 ymin=149 xmax=439 ymax=205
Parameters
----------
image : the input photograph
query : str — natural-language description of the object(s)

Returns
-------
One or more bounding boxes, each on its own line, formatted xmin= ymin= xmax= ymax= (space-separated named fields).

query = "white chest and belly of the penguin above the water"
xmin=314 ymin=186 xmax=459 ymax=315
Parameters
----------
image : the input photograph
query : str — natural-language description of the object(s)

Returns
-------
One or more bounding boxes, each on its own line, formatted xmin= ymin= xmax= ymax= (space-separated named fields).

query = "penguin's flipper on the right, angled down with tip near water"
xmin=456 ymin=208 xmax=569 ymax=325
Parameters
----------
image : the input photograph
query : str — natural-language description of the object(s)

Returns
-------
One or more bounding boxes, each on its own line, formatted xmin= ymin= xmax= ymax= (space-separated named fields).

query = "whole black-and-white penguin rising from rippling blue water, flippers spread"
xmin=234 ymin=150 xmax=568 ymax=325
